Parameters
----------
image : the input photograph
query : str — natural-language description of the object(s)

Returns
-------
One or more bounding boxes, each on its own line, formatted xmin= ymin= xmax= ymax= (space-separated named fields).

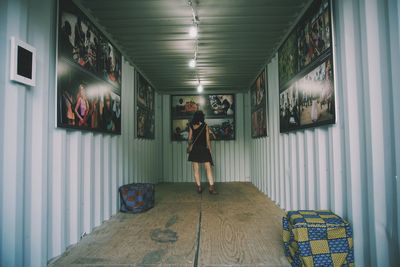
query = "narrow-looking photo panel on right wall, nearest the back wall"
xmin=250 ymin=70 xmax=268 ymax=138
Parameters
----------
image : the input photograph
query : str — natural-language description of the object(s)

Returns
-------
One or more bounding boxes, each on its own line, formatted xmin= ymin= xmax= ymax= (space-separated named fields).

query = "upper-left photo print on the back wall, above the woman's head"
xmin=171 ymin=95 xmax=206 ymax=117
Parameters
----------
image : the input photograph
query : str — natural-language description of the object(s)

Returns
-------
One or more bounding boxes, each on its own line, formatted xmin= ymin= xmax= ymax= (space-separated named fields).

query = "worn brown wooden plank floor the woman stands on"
xmin=49 ymin=183 xmax=289 ymax=266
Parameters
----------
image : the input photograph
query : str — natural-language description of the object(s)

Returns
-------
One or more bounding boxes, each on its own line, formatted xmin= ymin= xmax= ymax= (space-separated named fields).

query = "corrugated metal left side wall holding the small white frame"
xmin=0 ymin=0 xmax=162 ymax=266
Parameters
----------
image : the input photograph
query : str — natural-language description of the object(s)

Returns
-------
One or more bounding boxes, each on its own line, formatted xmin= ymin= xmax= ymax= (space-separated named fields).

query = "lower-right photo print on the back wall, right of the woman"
xmin=206 ymin=118 xmax=235 ymax=140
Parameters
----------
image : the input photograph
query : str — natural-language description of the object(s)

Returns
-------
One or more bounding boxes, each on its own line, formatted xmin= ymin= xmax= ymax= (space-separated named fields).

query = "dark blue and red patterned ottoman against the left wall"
xmin=118 ymin=183 xmax=154 ymax=213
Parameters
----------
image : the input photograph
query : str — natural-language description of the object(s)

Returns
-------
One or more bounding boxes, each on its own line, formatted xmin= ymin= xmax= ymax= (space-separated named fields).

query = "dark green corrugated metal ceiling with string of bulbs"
xmin=77 ymin=0 xmax=310 ymax=93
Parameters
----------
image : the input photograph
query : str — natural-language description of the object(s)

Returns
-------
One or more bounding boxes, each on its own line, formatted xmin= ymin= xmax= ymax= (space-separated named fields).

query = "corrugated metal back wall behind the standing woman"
xmin=162 ymin=92 xmax=250 ymax=182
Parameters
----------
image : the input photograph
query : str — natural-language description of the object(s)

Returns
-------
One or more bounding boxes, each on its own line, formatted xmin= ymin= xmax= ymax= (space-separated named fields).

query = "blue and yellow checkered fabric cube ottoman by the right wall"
xmin=282 ymin=210 xmax=354 ymax=267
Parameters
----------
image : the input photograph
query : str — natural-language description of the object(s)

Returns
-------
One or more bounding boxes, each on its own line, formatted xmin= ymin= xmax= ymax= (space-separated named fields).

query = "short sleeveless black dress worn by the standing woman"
xmin=188 ymin=124 xmax=214 ymax=165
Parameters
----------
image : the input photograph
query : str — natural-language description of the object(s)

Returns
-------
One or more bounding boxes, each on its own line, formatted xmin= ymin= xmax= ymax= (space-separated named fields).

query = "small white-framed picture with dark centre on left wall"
xmin=10 ymin=37 xmax=36 ymax=86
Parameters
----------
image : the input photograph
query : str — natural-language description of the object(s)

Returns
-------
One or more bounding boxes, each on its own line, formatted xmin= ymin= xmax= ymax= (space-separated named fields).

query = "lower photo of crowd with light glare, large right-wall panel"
xmin=279 ymin=57 xmax=336 ymax=132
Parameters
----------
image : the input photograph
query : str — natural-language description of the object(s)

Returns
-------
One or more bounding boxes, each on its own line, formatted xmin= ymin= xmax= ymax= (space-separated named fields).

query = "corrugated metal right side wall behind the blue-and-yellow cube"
xmin=251 ymin=0 xmax=400 ymax=266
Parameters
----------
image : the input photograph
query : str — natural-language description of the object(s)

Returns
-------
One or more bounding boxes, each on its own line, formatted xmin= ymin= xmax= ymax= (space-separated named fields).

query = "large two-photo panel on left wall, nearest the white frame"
xmin=56 ymin=0 xmax=122 ymax=134
